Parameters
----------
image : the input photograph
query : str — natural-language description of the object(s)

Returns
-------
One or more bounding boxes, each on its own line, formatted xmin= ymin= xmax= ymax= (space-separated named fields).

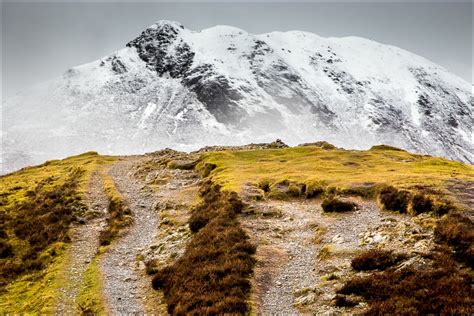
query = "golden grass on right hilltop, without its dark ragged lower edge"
xmin=197 ymin=146 xmax=474 ymax=192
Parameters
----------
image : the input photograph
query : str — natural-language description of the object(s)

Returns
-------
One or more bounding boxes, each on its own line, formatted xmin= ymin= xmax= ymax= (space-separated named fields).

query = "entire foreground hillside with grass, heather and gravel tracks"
xmin=0 ymin=141 xmax=474 ymax=314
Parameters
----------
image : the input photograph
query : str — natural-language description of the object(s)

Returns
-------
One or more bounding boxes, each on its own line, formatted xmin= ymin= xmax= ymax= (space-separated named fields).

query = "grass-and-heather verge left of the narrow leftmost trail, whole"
xmin=0 ymin=152 xmax=114 ymax=313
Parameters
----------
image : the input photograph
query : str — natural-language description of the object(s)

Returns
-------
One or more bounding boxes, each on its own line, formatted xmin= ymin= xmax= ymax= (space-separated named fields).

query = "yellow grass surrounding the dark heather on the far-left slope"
xmin=0 ymin=152 xmax=116 ymax=315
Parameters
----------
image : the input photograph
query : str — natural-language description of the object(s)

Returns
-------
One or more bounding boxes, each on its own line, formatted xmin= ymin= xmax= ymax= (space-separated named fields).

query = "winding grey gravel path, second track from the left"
xmin=100 ymin=157 xmax=159 ymax=315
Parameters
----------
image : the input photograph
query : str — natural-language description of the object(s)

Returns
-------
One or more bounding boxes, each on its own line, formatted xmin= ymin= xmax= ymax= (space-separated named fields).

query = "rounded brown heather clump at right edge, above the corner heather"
xmin=434 ymin=213 xmax=474 ymax=268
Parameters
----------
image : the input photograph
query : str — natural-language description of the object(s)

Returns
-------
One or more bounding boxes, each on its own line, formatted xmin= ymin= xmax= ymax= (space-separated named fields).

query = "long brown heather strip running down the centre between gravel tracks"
xmin=152 ymin=182 xmax=255 ymax=315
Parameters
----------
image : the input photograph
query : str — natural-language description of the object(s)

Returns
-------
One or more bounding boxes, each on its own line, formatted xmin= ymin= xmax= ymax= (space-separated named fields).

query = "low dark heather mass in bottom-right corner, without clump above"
xmin=338 ymin=253 xmax=474 ymax=315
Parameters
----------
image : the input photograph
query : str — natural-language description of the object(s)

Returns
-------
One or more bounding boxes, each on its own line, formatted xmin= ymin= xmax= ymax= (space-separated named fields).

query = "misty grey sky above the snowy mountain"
xmin=1 ymin=1 xmax=473 ymax=96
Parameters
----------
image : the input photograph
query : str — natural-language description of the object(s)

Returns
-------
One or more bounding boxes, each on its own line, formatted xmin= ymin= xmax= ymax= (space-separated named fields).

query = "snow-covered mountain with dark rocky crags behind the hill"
xmin=3 ymin=21 xmax=474 ymax=171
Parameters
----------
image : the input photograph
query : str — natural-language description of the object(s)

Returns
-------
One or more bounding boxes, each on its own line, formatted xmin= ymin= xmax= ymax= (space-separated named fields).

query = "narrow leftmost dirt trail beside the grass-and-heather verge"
xmin=55 ymin=172 xmax=108 ymax=315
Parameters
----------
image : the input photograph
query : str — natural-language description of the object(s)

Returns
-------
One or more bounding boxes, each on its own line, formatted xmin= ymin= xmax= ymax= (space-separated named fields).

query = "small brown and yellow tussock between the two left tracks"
xmin=99 ymin=174 xmax=133 ymax=246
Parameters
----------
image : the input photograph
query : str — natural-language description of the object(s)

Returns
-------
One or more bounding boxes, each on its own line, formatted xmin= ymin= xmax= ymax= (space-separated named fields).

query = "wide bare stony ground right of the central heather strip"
xmin=246 ymin=199 xmax=416 ymax=315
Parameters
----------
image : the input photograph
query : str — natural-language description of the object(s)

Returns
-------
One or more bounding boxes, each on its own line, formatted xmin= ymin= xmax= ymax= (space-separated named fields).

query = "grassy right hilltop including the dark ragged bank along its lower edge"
xmin=197 ymin=142 xmax=474 ymax=210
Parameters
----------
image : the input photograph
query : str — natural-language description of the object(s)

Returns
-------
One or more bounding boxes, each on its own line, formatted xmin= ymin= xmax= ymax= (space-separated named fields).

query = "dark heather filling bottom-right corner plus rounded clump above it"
xmin=338 ymin=213 xmax=474 ymax=315
